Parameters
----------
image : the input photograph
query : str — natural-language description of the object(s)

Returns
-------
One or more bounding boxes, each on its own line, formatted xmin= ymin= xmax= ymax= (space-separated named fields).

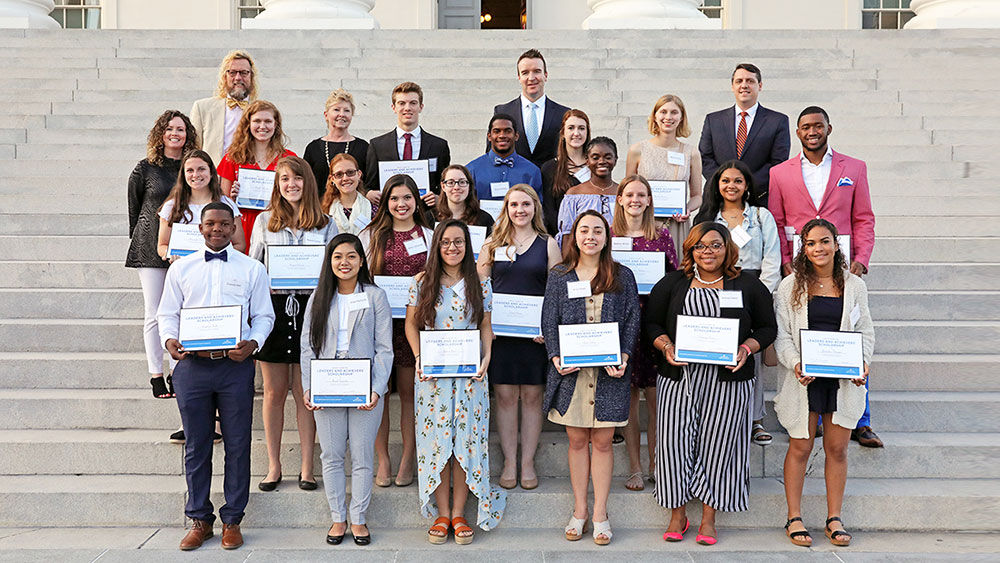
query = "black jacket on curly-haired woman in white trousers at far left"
xmin=125 ymin=158 xmax=181 ymax=268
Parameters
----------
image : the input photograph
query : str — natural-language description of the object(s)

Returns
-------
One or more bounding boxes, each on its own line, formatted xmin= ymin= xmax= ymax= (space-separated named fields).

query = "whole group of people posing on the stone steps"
xmin=126 ymin=49 xmax=881 ymax=549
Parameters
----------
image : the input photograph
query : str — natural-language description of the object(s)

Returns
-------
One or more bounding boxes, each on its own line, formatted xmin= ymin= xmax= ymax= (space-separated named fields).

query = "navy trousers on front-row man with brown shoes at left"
xmin=173 ymin=357 xmax=254 ymax=524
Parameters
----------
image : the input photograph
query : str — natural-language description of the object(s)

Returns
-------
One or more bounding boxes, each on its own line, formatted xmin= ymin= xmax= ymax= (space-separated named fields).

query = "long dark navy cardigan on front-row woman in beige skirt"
xmin=542 ymin=266 xmax=639 ymax=422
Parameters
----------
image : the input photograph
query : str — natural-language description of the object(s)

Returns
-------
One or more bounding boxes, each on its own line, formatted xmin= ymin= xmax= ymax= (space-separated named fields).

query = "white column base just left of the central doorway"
xmin=243 ymin=0 xmax=378 ymax=29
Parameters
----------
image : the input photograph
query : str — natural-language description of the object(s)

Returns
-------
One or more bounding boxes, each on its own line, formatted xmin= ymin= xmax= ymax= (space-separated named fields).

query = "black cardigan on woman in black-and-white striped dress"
xmin=643 ymin=270 xmax=778 ymax=381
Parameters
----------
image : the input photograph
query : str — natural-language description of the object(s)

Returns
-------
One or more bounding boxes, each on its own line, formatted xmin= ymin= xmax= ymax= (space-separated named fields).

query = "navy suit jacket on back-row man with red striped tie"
xmin=698 ymin=106 xmax=791 ymax=208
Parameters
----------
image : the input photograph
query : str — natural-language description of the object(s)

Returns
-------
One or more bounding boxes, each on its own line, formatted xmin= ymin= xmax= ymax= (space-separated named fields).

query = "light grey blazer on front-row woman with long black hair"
xmin=300 ymin=283 xmax=392 ymax=397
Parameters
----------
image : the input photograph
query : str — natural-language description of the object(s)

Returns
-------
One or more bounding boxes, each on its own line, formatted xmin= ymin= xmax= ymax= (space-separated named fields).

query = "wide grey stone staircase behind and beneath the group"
xmin=0 ymin=30 xmax=1000 ymax=531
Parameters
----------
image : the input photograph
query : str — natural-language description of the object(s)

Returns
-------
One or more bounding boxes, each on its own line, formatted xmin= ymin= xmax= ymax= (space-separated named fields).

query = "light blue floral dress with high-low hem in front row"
xmin=408 ymin=280 xmax=507 ymax=530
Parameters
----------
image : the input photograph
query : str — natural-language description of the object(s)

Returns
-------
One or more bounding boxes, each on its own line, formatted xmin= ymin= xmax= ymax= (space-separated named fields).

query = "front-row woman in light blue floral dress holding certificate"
xmin=406 ymin=219 xmax=507 ymax=545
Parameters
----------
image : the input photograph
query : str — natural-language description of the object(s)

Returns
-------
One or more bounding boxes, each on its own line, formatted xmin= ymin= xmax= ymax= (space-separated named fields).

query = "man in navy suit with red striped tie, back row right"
xmin=698 ymin=63 xmax=791 ymax=208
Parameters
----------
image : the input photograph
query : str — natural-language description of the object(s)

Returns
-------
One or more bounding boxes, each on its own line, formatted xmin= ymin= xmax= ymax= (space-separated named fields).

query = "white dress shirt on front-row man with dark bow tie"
xmin=156 ymin=244 xmax=274 ymax=347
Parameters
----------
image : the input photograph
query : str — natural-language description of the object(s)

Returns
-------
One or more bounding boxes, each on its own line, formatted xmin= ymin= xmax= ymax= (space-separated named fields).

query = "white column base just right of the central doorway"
xmin=583 ymin=0 xmax=722 ymax=29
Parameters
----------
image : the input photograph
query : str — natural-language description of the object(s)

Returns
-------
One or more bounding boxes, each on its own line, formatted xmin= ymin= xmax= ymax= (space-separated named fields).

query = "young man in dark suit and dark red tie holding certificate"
xmin=365 ymin=82 xmax=451 ymax=208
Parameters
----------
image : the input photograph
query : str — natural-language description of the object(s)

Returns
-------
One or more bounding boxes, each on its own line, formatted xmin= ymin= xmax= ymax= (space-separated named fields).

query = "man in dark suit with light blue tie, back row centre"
xmin=486 ymin=49 xmax=569 ymax=168
